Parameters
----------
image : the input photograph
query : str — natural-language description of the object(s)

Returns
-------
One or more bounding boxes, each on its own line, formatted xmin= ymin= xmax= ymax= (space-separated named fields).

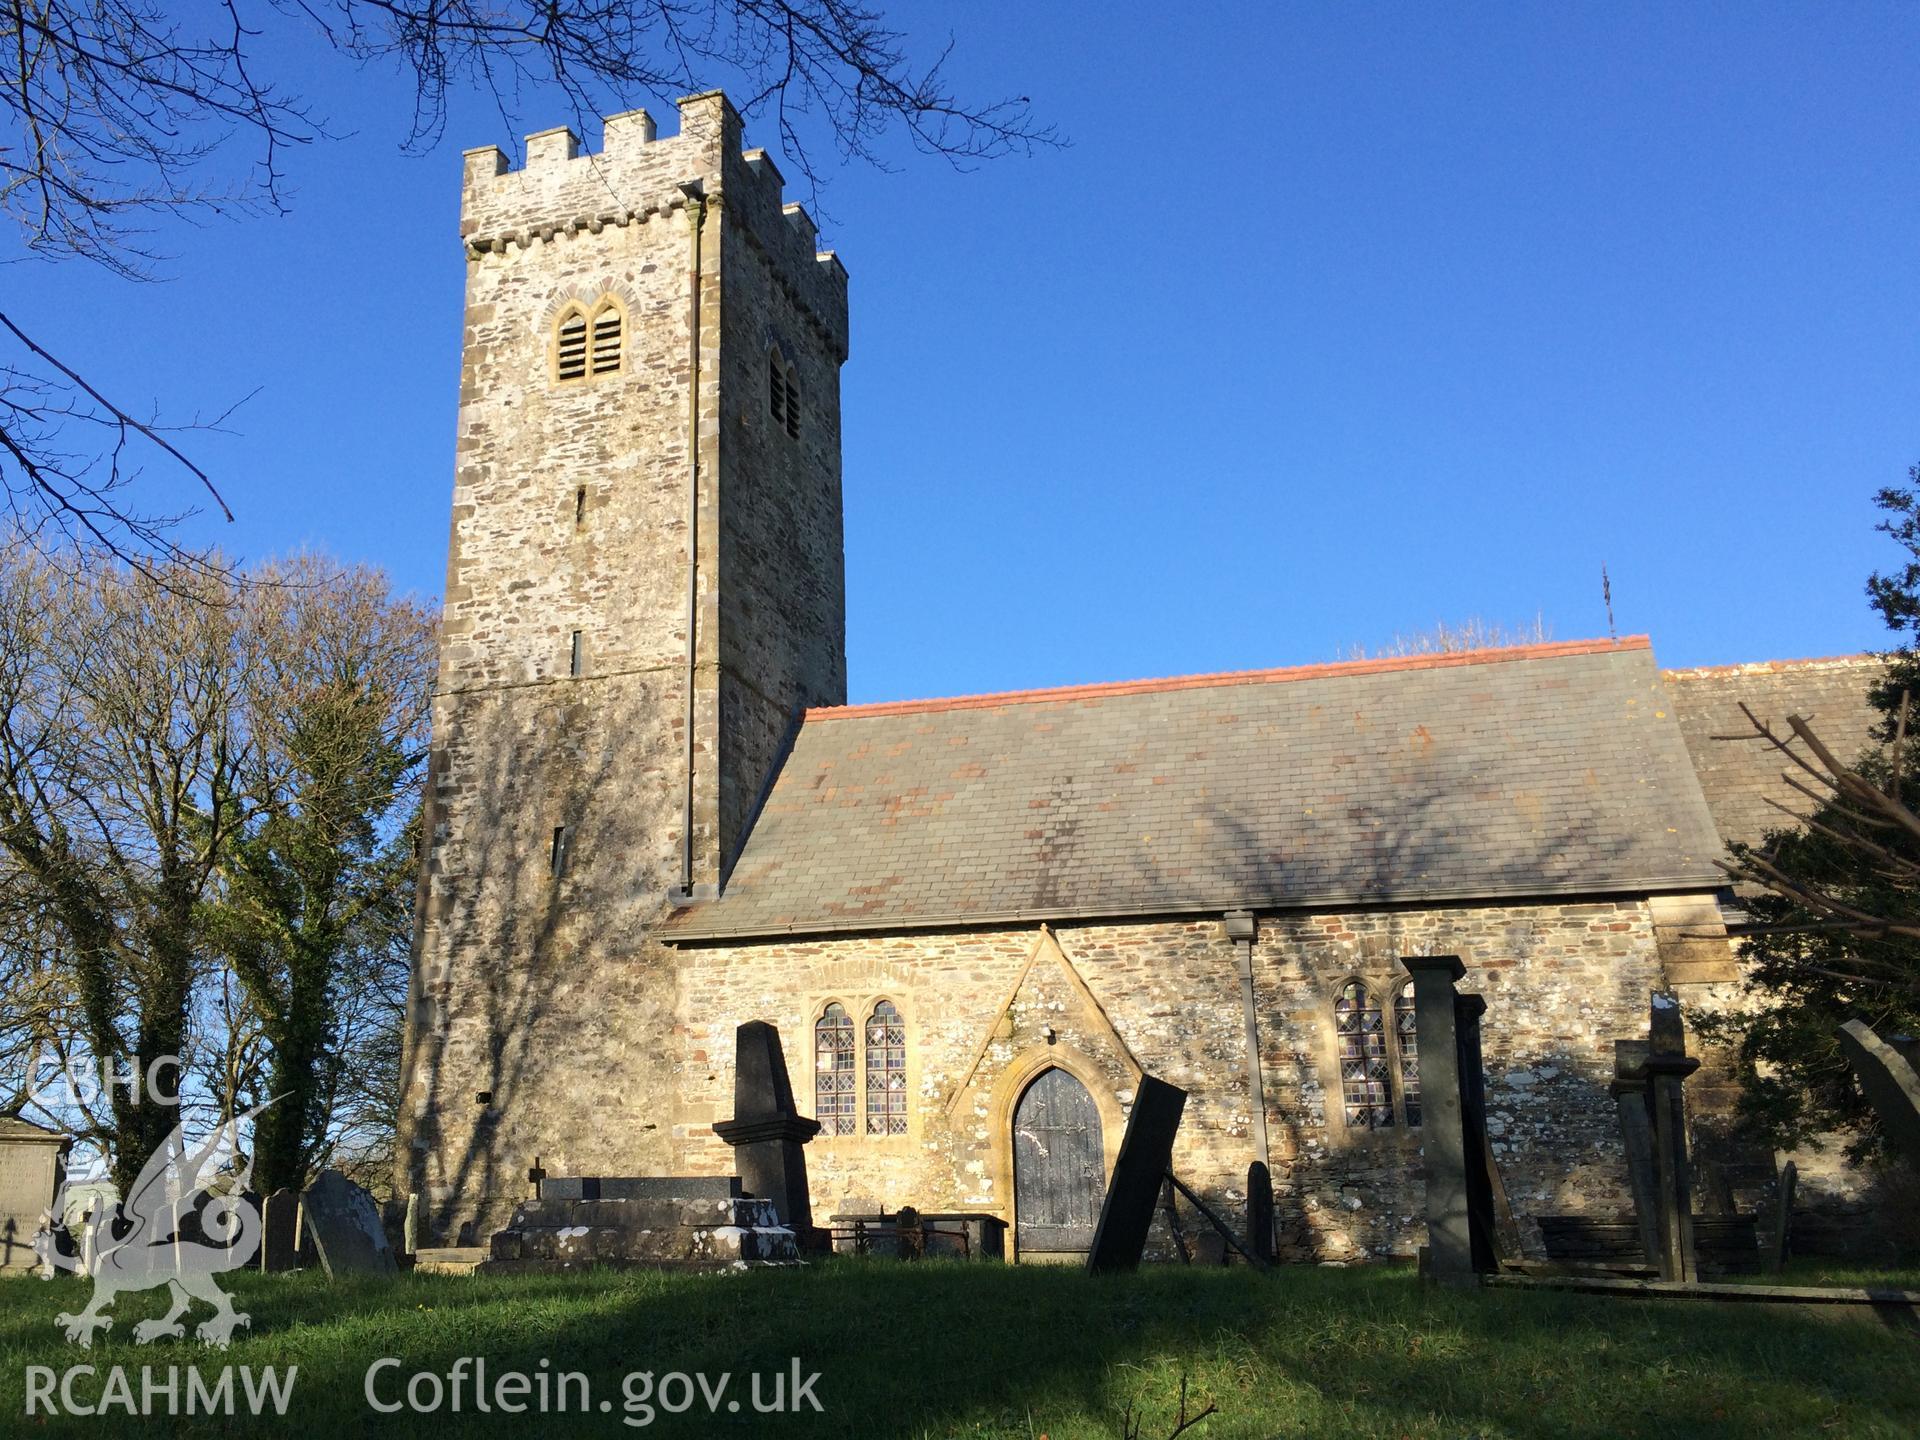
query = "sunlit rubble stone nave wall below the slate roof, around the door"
xmin=676 ymin=900 xmax=1661 ymax=1260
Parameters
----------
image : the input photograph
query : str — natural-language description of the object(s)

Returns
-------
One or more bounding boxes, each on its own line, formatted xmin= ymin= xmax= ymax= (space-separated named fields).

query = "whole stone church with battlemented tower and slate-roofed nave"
xmin=397 ymin=92 xmax=1874 ymax=1261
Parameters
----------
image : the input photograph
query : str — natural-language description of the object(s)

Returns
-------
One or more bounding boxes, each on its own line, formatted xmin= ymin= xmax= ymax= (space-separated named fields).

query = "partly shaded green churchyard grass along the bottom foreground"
xmin=0 ymin=1260 xmax=1920 ymax=1440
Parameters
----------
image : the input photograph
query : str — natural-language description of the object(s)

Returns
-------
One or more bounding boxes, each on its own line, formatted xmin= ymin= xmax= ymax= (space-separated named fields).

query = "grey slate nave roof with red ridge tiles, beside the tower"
xmin=662 ymin=636 xmax=1724 ymax=939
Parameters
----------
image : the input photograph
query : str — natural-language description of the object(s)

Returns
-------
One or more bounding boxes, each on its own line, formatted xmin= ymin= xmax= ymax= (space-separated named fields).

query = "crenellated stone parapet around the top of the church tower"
xmin=461 ymin=90 xmax=847 ymax=359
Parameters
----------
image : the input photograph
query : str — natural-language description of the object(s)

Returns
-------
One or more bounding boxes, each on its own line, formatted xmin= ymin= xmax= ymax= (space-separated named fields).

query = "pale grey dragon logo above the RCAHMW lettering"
xmin=35 ymin=1096 xmax=278 ymax=1346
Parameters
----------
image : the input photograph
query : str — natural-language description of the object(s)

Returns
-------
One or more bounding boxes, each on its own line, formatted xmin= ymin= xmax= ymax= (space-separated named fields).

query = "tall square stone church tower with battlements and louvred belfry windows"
xmin=397 ymin=94 xmax=847 ymax=1240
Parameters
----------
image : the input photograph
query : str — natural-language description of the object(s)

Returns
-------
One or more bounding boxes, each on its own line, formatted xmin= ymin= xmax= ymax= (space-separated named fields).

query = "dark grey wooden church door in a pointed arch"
xmin=1014 ymin=1066 xmax=1106 ymax=1260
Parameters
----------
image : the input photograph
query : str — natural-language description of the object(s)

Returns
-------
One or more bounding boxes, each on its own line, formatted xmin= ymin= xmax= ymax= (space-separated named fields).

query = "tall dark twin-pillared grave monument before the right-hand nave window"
xmin=1402 ymin=954 xmax=1498 ymax=1284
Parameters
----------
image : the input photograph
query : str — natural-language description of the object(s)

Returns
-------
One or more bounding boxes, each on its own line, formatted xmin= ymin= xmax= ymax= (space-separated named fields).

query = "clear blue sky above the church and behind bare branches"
xmin=11 ymin=2 xmax=1920 ymax=701
